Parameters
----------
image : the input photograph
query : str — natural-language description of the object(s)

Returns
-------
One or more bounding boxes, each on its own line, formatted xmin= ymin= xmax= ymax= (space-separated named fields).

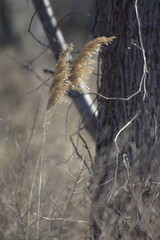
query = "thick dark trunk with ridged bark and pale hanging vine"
xmin=90 ymin=0 xmax=160 ymax=240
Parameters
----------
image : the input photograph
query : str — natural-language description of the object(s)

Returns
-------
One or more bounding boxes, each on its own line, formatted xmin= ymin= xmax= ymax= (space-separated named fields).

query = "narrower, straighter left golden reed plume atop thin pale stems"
xmin=47 ymin=44 xmax=73 ymax=110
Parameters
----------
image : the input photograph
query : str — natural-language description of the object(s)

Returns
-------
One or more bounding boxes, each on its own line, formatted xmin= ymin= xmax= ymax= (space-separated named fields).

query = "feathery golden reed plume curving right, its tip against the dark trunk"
xmin=70 ymin=37 xmax=115 ymax=89
